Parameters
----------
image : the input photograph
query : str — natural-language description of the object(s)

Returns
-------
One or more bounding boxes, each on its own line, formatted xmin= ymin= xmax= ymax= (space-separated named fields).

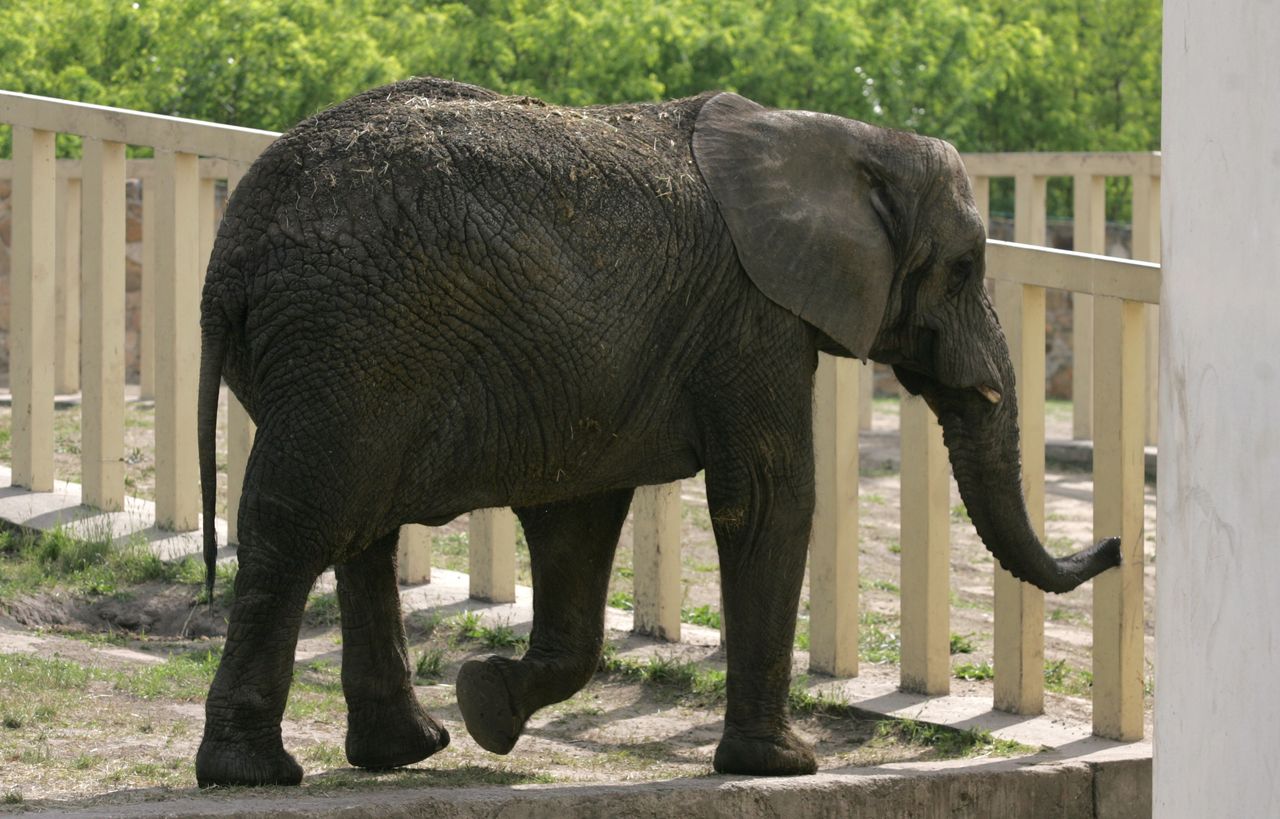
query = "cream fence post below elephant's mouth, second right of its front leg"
xmin=900 ymin=390 xmax=951 ymax=694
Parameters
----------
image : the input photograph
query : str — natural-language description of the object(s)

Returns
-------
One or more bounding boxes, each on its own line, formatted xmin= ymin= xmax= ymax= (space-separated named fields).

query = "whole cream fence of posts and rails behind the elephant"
xmin=0 ymin=92 xmax=1160 ymax=740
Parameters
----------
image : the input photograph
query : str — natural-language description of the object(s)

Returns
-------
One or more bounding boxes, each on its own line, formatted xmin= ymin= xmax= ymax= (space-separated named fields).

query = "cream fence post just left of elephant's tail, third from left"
xmin=155 ymin=150 xmax=200 ymax=531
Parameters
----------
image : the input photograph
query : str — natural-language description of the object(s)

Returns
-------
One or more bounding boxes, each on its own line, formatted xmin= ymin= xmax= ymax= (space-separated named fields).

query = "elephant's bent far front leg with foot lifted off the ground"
xmin=457 ymin=489 xmax=632 ymax=754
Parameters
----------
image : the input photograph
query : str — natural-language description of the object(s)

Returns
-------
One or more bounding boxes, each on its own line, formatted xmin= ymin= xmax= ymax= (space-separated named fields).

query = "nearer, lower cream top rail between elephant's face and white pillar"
xmin=987 ymin=239 xmax=1160 ymax=305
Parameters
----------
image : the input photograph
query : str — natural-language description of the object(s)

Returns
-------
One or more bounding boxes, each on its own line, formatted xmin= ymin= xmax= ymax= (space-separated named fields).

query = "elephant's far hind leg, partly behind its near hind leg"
xmin=334 ymin=531 xmax=449 ymax=768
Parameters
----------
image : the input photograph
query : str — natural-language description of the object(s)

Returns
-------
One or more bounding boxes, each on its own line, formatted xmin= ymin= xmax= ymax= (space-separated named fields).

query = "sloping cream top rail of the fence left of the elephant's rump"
xmin=0 ymin=91 xmax=280 ymax=161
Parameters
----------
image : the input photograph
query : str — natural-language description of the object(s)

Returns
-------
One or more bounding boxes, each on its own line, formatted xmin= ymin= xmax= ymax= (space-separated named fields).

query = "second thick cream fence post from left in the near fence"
xmin=81 ymin=137 xmax=127 ymax=511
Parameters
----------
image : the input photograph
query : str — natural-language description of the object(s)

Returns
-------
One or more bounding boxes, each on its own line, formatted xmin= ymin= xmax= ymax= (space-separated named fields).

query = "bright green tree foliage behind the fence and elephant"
xmin=0 ymin=0 xmax=1160 ymax=151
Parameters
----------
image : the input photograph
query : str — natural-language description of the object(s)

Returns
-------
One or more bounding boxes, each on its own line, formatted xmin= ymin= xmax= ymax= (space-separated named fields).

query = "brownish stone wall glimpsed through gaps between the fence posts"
xmin=0 ymin=189 xmax=1129 ymax=398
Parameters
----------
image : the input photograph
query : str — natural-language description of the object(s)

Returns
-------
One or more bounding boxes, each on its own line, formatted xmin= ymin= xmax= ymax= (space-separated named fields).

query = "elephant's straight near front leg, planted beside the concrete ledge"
xmin=707 ymin=443 xmax=817 ymax=775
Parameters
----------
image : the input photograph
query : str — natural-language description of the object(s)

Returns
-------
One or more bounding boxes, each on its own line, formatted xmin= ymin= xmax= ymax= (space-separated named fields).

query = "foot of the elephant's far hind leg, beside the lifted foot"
xmin=347 ymin=694 xmax=449 ymax=769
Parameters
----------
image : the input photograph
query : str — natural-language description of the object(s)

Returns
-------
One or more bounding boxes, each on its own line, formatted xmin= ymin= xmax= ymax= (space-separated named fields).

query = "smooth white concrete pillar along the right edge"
xmin=1153 ymin=0 xmax=1280 ymax=819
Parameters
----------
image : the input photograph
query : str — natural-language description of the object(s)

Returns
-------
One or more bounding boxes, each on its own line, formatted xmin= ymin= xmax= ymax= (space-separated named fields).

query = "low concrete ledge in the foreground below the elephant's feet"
xmin=47 ymin=759 xmax=1151 ymax=819
